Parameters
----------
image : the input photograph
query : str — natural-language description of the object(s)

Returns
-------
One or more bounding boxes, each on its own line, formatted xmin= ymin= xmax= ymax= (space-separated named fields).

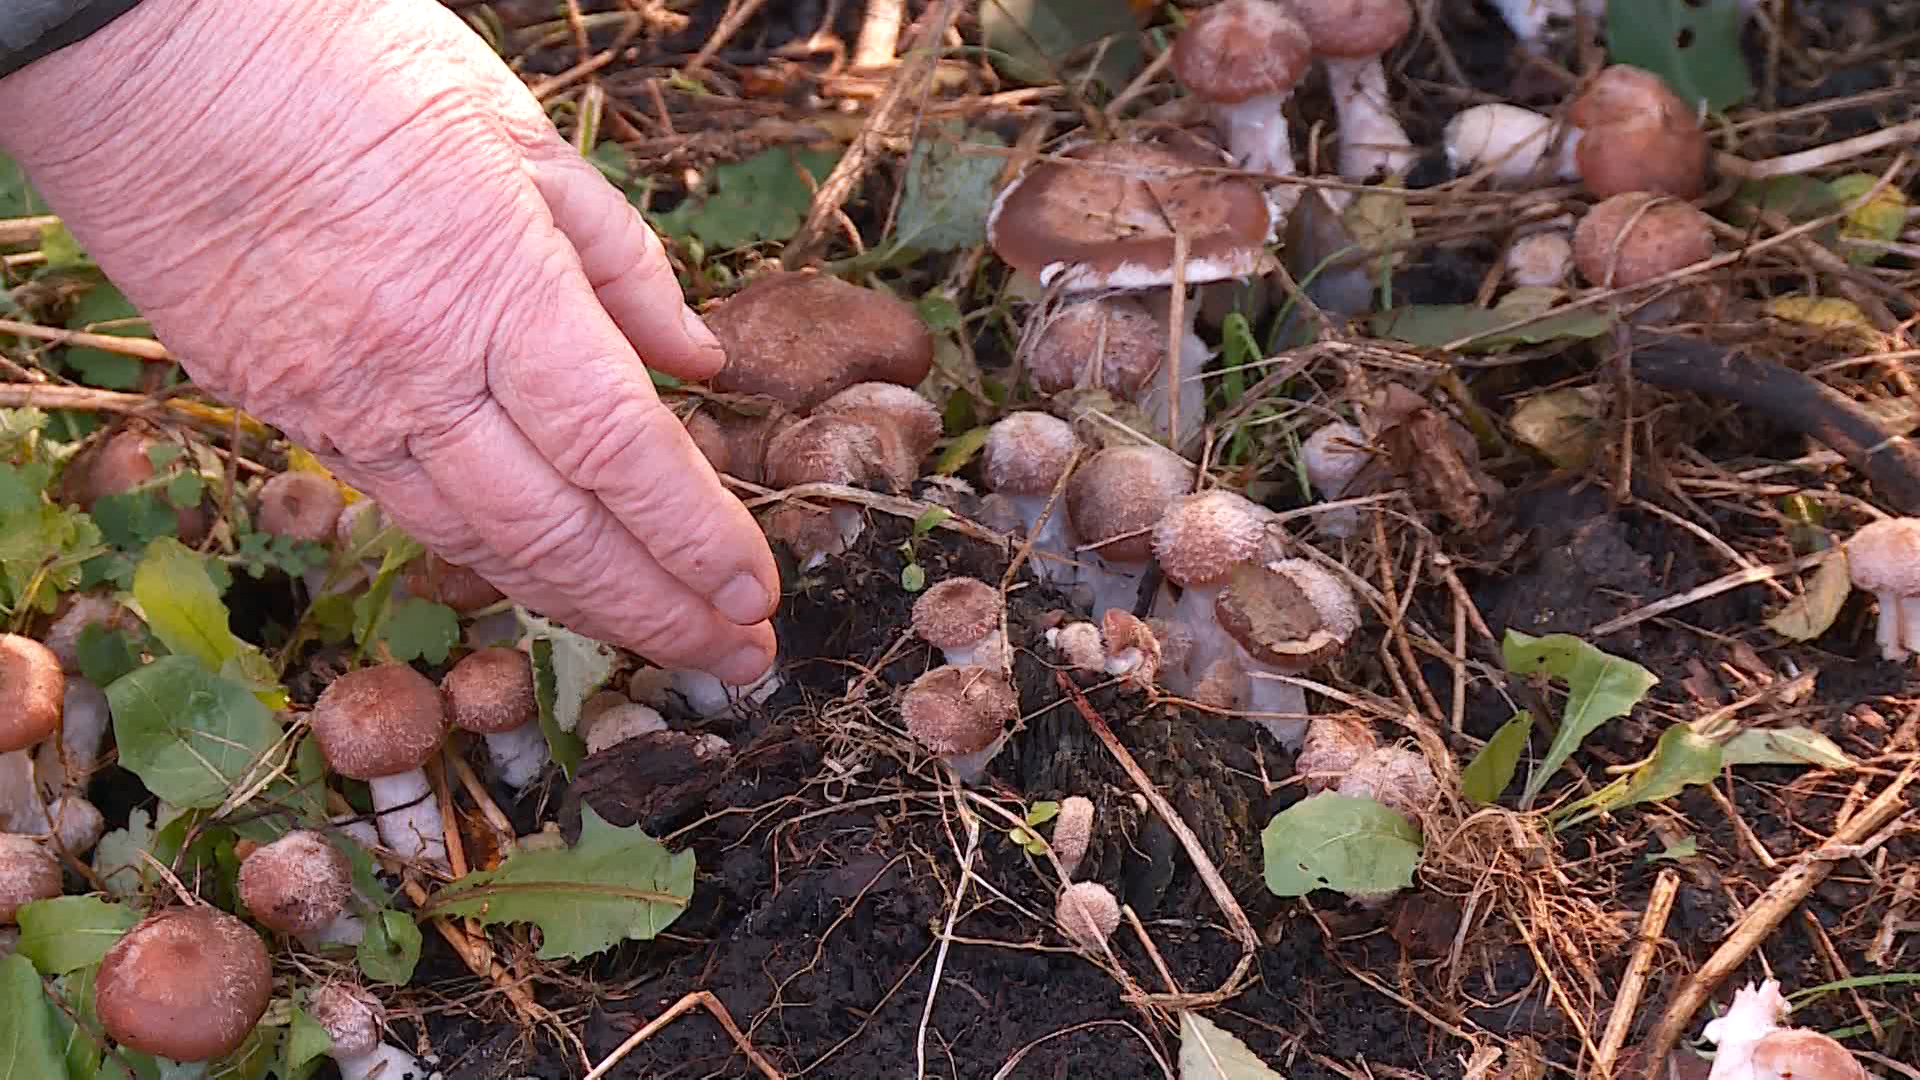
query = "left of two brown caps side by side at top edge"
xmin=1173 ymin=0 xmax=1317 ymax=104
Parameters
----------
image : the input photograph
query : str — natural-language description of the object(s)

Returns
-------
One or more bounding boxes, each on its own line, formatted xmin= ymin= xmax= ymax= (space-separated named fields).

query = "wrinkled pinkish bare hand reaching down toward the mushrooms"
xmin=0 ymin=0 xmax=778 ymax=682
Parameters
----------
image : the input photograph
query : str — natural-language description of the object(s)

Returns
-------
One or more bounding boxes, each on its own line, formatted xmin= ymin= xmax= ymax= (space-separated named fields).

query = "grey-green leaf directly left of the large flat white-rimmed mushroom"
xmin=885 ymin=123 xmax=1006 ymax=252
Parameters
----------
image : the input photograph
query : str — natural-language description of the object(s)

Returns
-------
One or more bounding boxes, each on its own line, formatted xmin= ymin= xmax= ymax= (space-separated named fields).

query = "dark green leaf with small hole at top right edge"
xmin=1607 ymin=0 xmax=1753 ymax=111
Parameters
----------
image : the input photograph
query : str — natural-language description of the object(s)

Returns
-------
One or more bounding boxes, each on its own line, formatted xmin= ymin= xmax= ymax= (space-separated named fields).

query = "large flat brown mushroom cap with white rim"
xmin=987 ymin=142 xmax=1275 ymax=288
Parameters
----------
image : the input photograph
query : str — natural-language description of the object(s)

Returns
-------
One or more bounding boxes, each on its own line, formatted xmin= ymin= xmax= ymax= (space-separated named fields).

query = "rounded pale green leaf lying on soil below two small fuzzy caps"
xmin=1260 ymin=792 xmax=1421 ymax=896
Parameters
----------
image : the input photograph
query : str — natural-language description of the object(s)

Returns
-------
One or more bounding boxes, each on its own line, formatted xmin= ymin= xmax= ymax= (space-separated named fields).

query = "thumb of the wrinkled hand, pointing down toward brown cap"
xmin=528 ymin=144 xmax=726 ymax=380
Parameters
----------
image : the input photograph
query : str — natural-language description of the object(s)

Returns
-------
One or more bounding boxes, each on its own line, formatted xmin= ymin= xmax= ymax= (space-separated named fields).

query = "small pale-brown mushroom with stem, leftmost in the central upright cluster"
xmin=979 ymin=411 xmax=1079 ymax=584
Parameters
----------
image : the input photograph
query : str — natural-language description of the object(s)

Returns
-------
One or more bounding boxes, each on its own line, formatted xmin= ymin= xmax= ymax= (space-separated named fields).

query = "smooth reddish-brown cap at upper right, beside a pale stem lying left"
xmin=1567 ymin=63 xmax=1707 ymax=198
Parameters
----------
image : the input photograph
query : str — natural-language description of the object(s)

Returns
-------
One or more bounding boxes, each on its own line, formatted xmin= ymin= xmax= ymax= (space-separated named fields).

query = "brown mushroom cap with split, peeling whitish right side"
xmin=1213 ymin=559 xmax=1359 ymax=671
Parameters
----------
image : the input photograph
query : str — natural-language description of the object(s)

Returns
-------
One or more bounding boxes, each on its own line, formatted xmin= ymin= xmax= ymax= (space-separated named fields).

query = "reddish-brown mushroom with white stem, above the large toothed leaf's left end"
xmin=309 ymin=663 xmax=447 ymax=865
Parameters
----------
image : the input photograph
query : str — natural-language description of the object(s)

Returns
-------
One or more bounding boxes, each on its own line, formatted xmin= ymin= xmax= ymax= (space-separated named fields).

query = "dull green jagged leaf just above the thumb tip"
xmin=653 ymin=146 xmax=839 ymax=250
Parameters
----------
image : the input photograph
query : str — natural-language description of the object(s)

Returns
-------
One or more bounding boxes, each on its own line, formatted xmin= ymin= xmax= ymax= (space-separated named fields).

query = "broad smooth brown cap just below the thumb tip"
xmin=707 ymin=271 xmax=933 ymax=411
